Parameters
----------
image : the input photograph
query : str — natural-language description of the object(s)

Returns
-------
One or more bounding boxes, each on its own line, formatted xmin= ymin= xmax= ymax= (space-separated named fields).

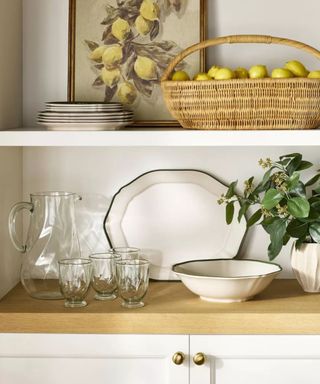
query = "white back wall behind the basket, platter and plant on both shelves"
xmin=23 ymin=0 xmax=320 ymax=276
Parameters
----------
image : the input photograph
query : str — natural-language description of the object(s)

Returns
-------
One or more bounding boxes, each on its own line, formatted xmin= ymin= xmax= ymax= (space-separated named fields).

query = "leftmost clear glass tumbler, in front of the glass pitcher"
xmin=59 ymin=259 xmax=92 ymax=308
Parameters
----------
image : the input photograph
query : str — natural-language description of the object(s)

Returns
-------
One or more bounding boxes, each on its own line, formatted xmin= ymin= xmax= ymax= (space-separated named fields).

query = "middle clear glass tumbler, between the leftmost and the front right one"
xmin=90 ymin=251 xmax=121 ymax=300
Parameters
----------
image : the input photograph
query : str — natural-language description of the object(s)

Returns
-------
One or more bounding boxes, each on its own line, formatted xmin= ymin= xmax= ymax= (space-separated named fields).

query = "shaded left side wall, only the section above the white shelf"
xmin=0 ymin=0 xmax=22 ymax=130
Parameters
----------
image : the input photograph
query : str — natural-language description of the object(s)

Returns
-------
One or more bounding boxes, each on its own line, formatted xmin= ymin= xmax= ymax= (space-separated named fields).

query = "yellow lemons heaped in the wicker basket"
xmin=171 ymin=60 xmax=320 ymax=81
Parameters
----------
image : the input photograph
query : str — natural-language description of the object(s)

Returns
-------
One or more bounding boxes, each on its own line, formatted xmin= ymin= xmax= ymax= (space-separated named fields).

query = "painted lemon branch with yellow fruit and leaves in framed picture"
xmin=86 ymin=0 xmax=190 ymax=105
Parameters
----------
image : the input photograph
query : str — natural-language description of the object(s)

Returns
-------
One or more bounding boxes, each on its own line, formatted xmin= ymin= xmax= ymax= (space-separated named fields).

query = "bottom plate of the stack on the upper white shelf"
xmin=38 ymin=121 xmax=131 ymax=131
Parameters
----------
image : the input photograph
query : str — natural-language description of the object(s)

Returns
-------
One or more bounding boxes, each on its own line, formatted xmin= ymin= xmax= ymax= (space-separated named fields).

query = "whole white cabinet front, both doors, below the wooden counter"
xmin=0 ymin=334 xmax=320 ymax=384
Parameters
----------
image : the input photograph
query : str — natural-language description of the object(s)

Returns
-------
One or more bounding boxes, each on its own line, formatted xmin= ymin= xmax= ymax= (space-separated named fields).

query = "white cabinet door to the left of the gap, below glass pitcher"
xmin=0 ymin=334 xmax=189 ymax=384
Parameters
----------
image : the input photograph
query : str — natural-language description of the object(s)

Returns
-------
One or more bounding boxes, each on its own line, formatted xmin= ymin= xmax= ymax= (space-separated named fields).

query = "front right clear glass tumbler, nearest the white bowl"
xmin=116 ymin=259 xmax=149 ymax=308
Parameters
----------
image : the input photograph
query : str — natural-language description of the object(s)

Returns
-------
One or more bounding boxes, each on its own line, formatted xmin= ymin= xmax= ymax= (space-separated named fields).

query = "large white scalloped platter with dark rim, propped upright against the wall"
xmin=104 ymin=170 xmax=246 ymax=280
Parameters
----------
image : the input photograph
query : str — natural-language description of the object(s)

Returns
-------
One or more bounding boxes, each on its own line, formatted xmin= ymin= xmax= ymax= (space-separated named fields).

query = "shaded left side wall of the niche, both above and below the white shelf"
xmin=0 ymin=0 xmax=22 ymax=298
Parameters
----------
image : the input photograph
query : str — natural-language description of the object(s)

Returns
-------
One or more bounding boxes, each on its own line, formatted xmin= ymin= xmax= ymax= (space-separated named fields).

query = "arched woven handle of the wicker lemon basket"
xmin=161 ymin=35 xmax=320 ymax=81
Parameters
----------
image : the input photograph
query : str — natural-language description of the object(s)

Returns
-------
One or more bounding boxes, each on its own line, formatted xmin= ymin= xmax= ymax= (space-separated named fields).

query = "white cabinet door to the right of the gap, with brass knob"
xmin=190 ymin=336 xmax=320 ymax=384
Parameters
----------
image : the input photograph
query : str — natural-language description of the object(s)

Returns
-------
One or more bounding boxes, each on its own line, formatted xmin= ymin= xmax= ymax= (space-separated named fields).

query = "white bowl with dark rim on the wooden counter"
xmin=172 ymin=259 xmax=282 ymax=303
